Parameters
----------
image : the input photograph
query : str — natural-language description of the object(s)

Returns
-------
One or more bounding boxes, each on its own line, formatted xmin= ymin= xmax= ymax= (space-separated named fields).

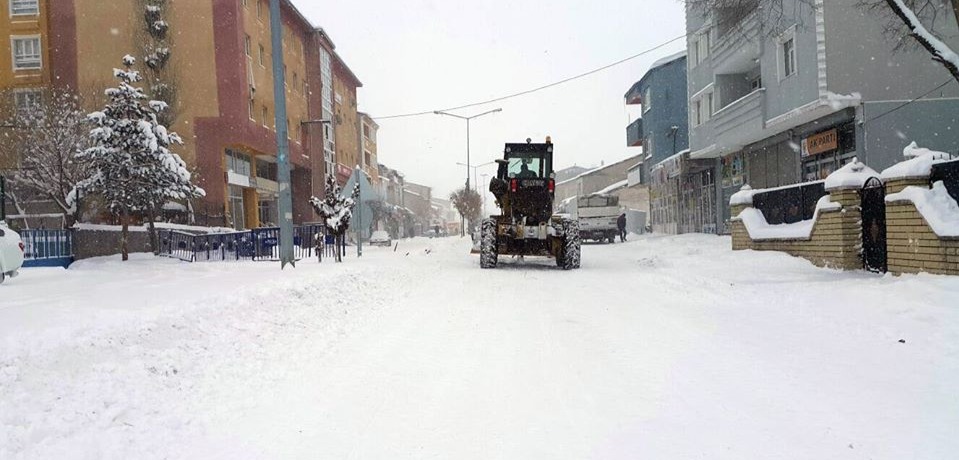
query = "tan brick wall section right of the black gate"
xmin=886 ymin=179 xmax=959 ymax=275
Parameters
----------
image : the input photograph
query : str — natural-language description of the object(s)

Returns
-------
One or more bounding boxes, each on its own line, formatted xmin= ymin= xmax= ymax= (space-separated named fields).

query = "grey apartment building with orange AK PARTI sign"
xmin=686 ymin=0 xmax=959 ymax=231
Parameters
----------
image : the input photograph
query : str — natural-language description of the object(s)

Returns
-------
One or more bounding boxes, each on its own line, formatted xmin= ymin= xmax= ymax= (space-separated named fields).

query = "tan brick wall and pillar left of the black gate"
xmin=732 ymin=189 xmax=863 ymax=270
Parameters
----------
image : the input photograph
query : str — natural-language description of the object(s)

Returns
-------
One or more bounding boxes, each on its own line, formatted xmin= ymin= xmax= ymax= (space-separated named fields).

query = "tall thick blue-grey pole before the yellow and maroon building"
xmin=270 ymin=0 xmax=296 ymax=270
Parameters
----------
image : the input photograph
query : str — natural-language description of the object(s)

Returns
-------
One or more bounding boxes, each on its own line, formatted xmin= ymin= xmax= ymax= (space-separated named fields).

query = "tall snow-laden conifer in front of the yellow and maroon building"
xmin=79 ymin=55 xmax=204 ymax=260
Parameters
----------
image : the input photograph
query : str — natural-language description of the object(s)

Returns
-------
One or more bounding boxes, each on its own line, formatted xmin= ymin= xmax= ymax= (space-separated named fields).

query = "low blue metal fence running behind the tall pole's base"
xmin=159 ymin=225 xmax=326 ymax=262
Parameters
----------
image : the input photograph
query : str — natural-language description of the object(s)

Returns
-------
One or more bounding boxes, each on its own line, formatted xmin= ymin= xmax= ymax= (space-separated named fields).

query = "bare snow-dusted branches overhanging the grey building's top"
xmin=684 ymin=0 xmax=959 ymax=81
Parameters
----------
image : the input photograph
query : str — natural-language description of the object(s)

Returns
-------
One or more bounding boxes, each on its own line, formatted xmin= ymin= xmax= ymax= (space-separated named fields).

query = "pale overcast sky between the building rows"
xmin=294 ymin=0 xmax=685 ymax=197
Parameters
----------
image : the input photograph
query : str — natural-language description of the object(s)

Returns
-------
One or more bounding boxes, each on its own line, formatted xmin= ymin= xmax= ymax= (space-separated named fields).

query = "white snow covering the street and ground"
xmin=0 ymin=235 xmax=959 ymax=459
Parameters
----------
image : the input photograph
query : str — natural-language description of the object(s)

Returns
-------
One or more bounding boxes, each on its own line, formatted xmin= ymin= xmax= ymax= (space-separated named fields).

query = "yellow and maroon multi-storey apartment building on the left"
xmin=0 ymin=0 xmax=372 ymax=229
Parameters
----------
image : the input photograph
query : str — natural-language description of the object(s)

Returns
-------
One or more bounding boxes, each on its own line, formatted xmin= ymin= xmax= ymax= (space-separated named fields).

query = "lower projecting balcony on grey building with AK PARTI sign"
xmin=710 ymin=88 xmax=766 ymax=151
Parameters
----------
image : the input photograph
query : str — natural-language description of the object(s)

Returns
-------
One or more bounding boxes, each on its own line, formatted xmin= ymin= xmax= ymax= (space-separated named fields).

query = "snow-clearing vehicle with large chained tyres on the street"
xmin=480 ymin=138 xmax=580 ymax=270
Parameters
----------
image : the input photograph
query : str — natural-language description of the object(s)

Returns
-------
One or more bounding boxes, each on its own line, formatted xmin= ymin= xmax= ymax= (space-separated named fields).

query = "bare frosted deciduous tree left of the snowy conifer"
xmin=0 ymin=89 xmax=90 ymax=225
